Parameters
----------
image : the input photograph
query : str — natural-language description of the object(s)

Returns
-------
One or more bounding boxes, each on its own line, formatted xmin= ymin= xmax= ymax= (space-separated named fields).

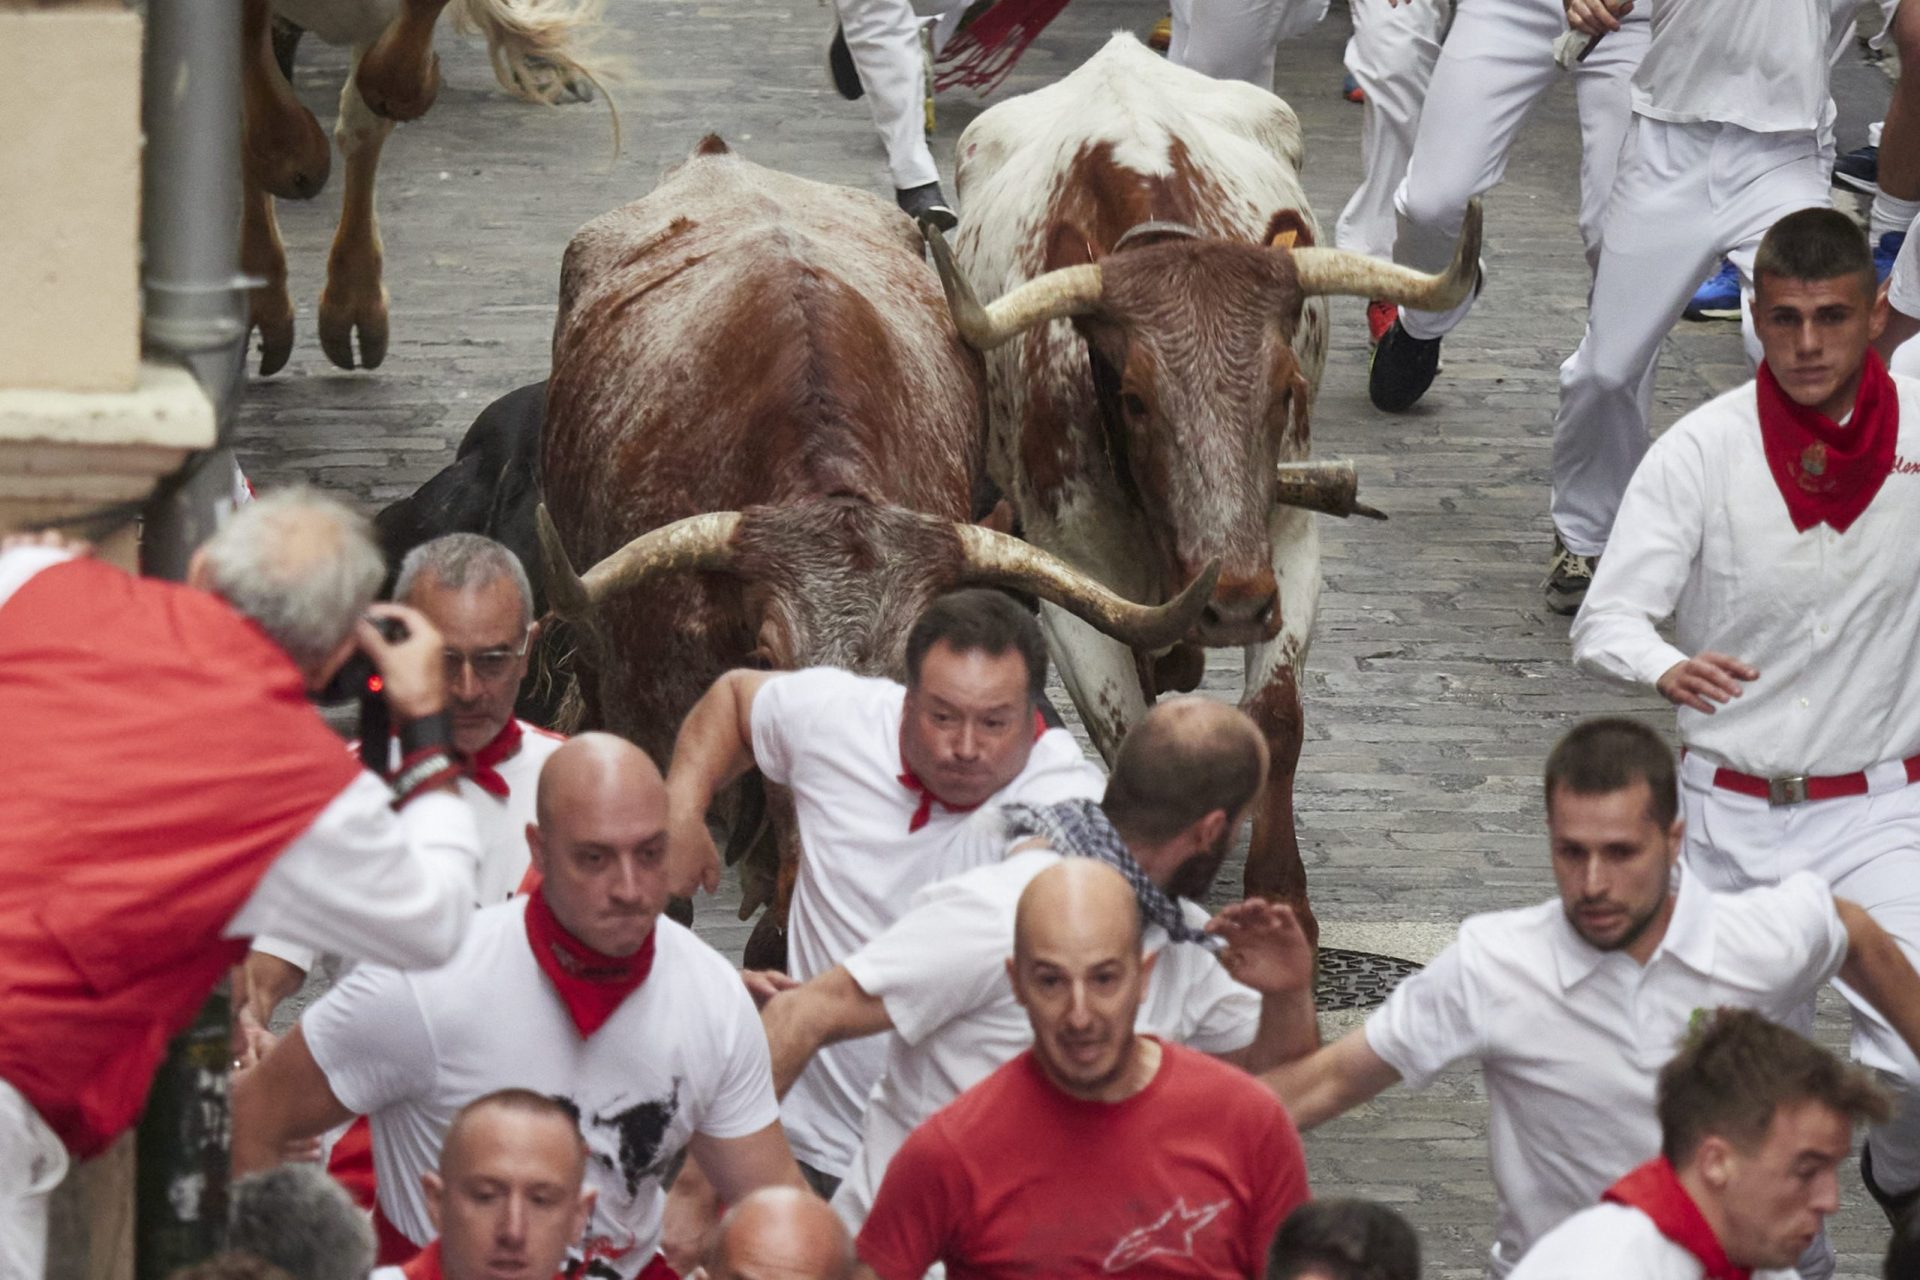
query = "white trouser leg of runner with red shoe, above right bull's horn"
xmin=1332 ymin=0 xmax=1452 ymax=257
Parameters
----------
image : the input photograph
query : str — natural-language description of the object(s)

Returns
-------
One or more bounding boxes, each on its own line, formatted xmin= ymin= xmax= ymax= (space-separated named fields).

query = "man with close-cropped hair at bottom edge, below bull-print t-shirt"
xmin=369 ymin=1088 xmax=593 ymax=1280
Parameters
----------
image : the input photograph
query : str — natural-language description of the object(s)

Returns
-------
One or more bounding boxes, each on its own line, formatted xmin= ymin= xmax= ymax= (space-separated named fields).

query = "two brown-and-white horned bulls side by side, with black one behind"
xmin=349 ymin=35 xmax=1478 ymax=960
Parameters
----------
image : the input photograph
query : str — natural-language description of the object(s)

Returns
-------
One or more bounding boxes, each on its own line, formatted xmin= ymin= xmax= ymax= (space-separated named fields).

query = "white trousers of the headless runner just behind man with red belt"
xmin=1553 ymin=115 xmax=1832 ymax=555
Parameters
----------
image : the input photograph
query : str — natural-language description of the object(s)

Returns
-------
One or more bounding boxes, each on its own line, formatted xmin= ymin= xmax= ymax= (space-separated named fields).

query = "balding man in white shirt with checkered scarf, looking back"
xmin=748 ymin=699 xmax=1315 ymax=1230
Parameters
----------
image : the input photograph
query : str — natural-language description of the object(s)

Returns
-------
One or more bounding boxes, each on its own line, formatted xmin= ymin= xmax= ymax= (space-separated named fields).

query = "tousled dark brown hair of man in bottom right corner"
xmin=1659 ymin=1009 xmax=1893 ymax=1167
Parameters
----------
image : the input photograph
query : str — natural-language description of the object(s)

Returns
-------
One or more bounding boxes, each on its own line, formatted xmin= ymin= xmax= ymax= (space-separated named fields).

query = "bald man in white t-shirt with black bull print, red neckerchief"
xmin=232 ymin=733 xmax=801 ymax=1280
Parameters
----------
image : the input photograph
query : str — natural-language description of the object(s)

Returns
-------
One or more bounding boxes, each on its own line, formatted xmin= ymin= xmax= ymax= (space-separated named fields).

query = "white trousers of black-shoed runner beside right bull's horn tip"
xmin=1394 ymin=0 xmax=1651 ymax=338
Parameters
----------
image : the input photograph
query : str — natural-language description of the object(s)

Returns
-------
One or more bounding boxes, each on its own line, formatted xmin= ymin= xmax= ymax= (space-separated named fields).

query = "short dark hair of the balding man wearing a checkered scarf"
xmin=1100 ymin=699 xmax=1265 ymax=842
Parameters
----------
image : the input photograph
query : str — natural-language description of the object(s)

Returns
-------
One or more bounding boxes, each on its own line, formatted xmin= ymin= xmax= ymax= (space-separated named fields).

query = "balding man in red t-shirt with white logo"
xmin=856 ymin=858 xmax=1308 ymax=1280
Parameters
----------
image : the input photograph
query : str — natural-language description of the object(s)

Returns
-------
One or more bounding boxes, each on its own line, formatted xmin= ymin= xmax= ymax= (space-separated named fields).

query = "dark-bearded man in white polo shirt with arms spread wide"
xmin=1267 ymin=720 xmax=1920 ymax=1278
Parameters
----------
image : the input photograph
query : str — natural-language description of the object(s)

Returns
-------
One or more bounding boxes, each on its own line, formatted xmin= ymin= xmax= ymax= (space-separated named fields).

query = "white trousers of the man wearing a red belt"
xmin=1680 ymin=756 xmax=1920 ymax=1194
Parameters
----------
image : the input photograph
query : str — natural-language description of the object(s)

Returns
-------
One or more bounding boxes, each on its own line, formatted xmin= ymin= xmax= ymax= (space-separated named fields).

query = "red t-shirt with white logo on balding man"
xmin=858 ymin=1044 xmax=1308 ymax=1280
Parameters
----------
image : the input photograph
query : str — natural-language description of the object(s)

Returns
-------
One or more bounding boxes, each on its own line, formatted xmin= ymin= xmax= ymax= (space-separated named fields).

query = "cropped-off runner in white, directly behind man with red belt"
xmin=1546 ymin=0 xmax=1851 ymax=614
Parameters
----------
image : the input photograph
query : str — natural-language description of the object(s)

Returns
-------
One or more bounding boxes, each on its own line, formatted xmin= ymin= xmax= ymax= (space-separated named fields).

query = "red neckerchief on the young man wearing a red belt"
xmin=1753 ymin=347 xmax=1901 ymax=533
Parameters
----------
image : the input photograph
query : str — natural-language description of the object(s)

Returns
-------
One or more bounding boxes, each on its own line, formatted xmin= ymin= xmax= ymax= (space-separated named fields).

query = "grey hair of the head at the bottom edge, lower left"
xmin=227 ymin=1165 xmax=374 ymax=1280
